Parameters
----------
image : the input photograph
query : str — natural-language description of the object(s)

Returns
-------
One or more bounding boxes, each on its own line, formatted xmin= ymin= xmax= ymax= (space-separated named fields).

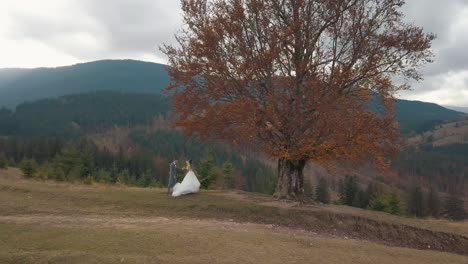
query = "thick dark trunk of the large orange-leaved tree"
xmin=276 ymin=158 xmax=306 ymax=200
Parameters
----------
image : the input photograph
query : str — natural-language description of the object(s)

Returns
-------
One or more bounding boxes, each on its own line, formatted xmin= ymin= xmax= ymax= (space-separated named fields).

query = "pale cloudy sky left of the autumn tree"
xmin=0 ymin=0 xmax=181 ymax=67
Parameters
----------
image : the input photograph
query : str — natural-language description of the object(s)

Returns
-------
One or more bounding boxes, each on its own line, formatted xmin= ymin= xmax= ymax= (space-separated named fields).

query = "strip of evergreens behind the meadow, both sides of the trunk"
xmin=0 ymin=140 xmax=468 ymax=220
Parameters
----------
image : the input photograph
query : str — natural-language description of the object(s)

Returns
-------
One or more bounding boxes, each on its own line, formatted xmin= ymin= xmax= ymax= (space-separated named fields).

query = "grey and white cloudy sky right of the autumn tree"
xmin=400 ymin=0 xmax=468 ymax=106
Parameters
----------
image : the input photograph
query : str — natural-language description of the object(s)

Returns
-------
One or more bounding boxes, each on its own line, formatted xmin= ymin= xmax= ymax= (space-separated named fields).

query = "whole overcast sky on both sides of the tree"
xmin=0 ymin=0 xmax=468 ymax=107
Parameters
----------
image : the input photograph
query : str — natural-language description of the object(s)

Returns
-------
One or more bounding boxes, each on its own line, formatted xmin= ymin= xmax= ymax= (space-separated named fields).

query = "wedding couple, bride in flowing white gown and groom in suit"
xmin=167 ymin=160 xmax=200 ymax=197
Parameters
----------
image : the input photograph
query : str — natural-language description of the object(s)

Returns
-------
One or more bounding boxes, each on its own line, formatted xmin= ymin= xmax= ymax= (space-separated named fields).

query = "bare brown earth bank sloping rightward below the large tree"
xmin=214 ymin=191 xmax=468 ymax=255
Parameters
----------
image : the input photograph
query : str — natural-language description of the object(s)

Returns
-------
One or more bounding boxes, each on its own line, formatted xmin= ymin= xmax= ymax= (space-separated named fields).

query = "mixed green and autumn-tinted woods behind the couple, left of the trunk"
xmin=0 ymin=134 xmax=276 ymax=194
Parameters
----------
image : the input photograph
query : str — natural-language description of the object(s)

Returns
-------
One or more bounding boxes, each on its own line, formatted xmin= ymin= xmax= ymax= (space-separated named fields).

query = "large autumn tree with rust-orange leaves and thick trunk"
xmin=163 ymin=0 xmax=434 ymax=199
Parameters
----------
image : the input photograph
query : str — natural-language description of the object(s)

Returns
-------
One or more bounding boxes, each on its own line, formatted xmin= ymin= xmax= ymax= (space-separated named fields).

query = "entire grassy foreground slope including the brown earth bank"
xmin=0 ymin=169 xmax=468 ymax=264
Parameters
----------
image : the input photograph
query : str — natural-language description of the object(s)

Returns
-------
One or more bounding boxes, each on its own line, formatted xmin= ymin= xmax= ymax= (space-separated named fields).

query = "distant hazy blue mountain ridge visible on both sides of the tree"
xmin=0 ymin=59 xmax=466 ymax=134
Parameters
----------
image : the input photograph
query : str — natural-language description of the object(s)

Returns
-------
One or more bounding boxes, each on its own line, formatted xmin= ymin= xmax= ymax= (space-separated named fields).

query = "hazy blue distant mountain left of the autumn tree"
xmin=0 ymin=60 xmax=169 ymax=108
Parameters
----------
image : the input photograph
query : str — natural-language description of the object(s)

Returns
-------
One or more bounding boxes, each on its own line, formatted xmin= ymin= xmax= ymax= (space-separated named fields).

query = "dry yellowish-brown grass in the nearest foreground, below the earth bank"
xmin=0 ymin=217 xmax=467 ymax=264
